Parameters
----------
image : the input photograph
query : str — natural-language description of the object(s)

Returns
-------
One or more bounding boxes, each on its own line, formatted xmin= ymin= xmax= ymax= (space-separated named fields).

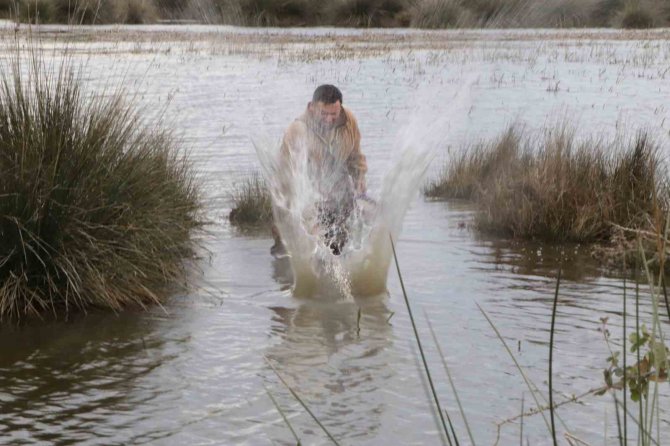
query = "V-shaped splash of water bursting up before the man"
xmin=254 ymin=132 xmax=431 ymax=300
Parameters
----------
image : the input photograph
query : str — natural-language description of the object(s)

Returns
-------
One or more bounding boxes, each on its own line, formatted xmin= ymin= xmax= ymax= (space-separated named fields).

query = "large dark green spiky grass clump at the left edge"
xmin=0 ymin=50 xmax=203 ymax=320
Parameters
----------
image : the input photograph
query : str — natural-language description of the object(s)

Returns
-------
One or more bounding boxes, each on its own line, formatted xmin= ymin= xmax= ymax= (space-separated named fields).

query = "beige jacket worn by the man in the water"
xmin=281 ymin=107 xmax=368 ymax=193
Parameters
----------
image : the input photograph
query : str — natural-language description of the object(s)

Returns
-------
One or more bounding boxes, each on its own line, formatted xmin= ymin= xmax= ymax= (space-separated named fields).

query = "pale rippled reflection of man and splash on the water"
xmin=265 ymin=259 xmax=394 ymax=441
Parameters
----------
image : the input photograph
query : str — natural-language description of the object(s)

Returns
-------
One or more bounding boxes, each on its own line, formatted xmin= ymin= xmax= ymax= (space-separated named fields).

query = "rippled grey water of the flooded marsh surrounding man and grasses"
xmin=0 ymin=25 xmax=670 ymax=445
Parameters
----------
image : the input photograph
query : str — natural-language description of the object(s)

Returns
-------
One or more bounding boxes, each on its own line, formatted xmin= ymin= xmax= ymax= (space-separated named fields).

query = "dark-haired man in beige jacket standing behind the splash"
xmin=271 ymin=85 xmax=367 ymax=254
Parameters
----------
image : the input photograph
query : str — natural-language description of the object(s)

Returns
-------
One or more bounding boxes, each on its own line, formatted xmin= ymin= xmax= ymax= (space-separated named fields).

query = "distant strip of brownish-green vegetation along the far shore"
xmin=7 ymin=0 xmax=670 ymax=28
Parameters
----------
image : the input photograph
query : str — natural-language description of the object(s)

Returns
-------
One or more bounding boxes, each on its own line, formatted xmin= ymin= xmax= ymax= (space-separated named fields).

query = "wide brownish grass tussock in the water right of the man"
xmin=424 ymin=126 xmax=670 ymax=242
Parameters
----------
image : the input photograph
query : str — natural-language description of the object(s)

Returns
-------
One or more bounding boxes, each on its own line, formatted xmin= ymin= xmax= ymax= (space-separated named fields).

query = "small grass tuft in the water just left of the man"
xmin=228 ymin=173 xmax=272 ymax=226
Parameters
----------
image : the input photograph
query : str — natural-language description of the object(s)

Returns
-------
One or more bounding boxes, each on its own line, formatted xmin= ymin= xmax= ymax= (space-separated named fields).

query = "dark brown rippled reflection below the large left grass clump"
xmin=0 ymin=312 xmax=192 ymax=444
